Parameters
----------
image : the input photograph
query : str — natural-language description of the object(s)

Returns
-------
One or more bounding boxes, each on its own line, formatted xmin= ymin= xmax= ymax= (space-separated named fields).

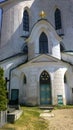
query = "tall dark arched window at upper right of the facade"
xmin=55 ymin=8 xmax=62 ymax=30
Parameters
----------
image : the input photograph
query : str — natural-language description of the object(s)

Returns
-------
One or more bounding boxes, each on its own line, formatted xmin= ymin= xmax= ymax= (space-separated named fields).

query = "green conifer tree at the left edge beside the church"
xmin=0 ymin=67 xmax=7 ymax=111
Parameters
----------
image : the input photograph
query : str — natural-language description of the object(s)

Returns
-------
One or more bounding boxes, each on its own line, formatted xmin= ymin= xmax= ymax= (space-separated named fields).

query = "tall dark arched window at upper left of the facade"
xmin=23 ymin=10 xmax=29 ymax=31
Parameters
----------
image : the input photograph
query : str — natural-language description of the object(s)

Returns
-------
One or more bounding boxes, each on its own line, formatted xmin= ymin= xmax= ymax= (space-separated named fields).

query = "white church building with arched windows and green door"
xmin=0 ymin=0 xmax=73 ymax=106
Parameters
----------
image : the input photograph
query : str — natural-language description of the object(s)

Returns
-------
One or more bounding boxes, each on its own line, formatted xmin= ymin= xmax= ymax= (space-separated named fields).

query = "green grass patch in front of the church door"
xmin=0 ymin=107 xmax=49 ymax=130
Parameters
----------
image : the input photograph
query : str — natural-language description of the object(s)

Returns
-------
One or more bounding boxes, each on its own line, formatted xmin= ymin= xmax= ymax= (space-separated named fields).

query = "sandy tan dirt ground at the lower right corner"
xmin=46 ymin=109 xmax=73 ymax=130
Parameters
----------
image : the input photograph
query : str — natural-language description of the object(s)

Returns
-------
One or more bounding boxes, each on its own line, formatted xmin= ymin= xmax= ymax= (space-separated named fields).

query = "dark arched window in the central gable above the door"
xmin=39 ymin=32 xmax=48 ymax=54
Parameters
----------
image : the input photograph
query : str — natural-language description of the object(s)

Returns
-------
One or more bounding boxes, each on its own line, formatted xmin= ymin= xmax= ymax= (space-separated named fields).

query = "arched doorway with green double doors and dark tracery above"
xmin=40 ymin=71 xmax=52 ymax=105
